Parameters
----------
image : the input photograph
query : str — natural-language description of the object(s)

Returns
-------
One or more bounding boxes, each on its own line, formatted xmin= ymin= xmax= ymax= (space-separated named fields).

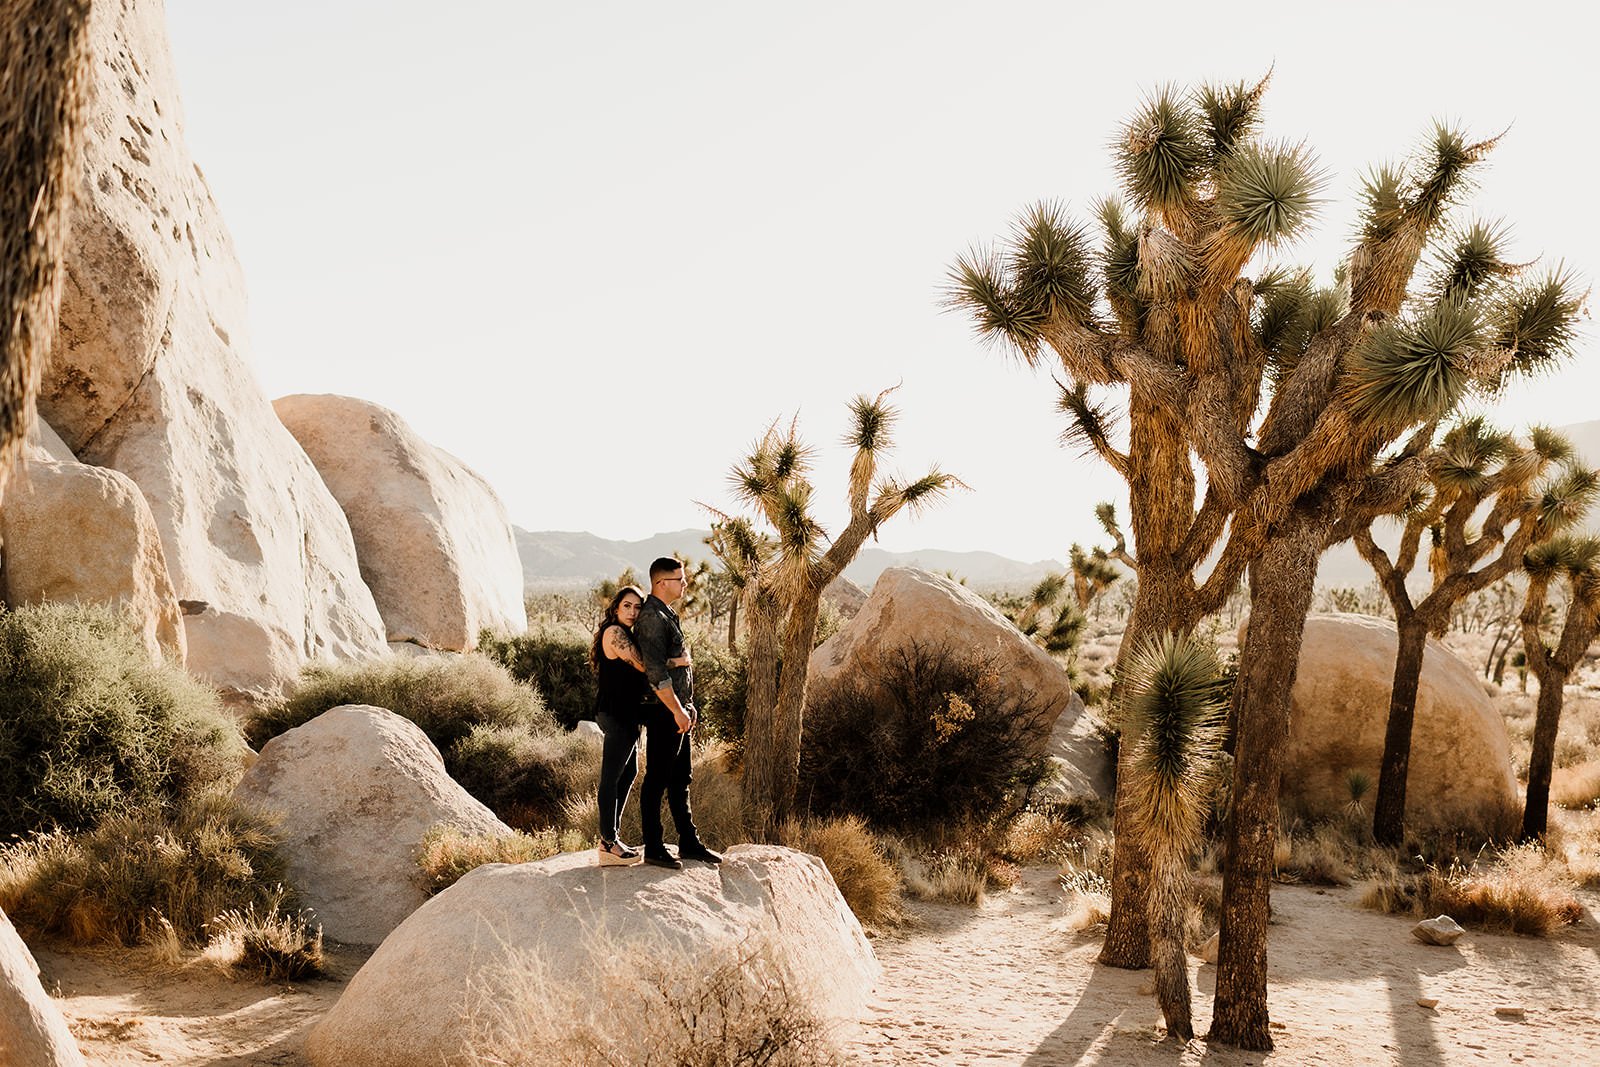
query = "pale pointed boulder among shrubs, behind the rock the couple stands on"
xmin=234 ymin=704 xmax=510 ymax=944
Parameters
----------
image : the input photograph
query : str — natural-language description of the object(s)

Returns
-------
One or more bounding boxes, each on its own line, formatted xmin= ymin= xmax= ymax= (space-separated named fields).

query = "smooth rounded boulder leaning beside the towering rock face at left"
xmin=272 ymin=395 xmax=528 ymax=651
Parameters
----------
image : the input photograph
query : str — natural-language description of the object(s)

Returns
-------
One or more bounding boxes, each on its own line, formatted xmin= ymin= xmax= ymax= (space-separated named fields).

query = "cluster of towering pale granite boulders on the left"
xmin=0 ymin=3 xmax=525 ymax=704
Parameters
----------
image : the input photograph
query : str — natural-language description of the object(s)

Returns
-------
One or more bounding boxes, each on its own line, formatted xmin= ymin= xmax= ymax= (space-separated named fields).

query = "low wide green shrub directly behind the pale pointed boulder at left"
xmin=245 ymin=654 xmax=552 ymax=752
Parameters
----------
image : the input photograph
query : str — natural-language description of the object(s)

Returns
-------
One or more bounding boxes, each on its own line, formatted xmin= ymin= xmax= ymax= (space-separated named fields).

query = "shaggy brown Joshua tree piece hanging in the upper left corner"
xmin=0 ymin=0 xmax=91 ymax=498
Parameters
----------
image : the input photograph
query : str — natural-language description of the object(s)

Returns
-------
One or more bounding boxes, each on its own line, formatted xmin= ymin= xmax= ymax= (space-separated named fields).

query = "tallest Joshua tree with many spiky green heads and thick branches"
xmin=955 ymin=75 xmax=1582 ymax=1049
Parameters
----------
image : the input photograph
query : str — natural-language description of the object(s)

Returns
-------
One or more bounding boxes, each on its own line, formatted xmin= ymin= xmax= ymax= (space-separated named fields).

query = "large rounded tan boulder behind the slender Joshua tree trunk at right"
xmin=1280 ymin=614 xmax=1517 ymax=832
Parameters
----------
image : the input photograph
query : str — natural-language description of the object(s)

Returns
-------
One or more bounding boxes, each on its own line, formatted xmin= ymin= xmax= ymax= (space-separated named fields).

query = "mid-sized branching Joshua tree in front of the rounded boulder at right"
xmin=1355 ymin=422 xmax=1600 ymax=845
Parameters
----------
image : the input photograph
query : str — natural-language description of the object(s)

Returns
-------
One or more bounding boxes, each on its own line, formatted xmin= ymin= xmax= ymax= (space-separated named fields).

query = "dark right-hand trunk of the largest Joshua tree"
xmin=1210 ymin=512 xmax=1325 ymax=1051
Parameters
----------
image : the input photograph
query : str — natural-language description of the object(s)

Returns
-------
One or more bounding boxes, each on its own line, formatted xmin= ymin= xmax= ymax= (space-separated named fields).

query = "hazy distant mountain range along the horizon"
xmin=515 ymin=421 xmax=1600 ymax=590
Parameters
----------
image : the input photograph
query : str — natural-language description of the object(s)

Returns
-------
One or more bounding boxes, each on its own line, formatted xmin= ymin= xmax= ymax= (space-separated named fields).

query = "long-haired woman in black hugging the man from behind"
xmin=589 ymin=585 xmax=650 ymax=867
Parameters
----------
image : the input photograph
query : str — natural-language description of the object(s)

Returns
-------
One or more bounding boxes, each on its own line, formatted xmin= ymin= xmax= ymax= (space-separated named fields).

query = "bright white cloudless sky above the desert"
xmin=166 ymin=0 xmax=1600 ymax=560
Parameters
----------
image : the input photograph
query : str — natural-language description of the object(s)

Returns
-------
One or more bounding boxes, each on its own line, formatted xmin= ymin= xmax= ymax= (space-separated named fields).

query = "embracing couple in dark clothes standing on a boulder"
xmin=589 ymin=557 xmax=722 ymax=870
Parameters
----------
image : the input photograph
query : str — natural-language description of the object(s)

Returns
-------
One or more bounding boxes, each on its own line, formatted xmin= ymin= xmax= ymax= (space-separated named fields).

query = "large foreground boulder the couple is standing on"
xmin=306 ymin=845 xmax=878 ymax=1067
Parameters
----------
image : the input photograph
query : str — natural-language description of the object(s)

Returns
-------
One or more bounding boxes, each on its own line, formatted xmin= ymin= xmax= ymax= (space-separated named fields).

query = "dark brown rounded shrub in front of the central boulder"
xmin=800 ymin=643 xmax=1048 ymax=833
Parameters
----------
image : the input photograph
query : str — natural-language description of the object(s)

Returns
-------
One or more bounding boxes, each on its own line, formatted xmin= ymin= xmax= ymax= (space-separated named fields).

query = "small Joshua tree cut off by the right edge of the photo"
xmin=1522 ymin=537 xmax=1600 ymax=840
